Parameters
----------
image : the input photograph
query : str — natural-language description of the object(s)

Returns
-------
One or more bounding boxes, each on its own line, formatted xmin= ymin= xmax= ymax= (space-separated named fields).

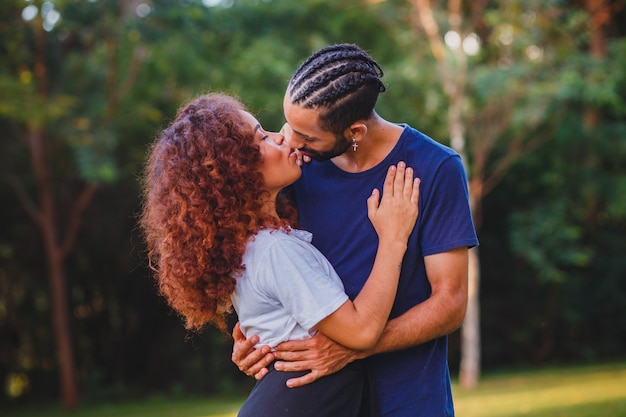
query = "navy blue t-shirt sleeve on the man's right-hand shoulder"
xmin=419 ymin=155 xmax=478 ymax=256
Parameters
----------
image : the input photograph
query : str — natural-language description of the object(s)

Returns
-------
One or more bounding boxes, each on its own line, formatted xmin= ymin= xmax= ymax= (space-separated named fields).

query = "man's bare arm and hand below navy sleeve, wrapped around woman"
xmin=275 ymin=247 xmax=468 ymax=387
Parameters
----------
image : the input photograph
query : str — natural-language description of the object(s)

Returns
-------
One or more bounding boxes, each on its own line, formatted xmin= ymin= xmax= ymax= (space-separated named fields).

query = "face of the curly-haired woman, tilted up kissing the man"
xmin=239 ymin=112 xmax=302 ymax=192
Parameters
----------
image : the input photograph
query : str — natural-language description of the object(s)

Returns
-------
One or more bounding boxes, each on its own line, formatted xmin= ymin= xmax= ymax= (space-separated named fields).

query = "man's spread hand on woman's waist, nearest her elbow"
xmin=274 ymin=332 xmax=360 ymax=388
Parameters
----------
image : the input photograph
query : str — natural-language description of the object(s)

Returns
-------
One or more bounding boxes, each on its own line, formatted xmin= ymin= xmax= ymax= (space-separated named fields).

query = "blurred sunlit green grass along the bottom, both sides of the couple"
xmin=2 ymin=363 xmax=626 ymax=417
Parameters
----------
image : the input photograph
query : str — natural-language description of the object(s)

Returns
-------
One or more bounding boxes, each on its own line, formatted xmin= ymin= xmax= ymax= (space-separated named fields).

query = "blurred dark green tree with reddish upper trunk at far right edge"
xmin=510 ymin=7 xmax=626 ymax=362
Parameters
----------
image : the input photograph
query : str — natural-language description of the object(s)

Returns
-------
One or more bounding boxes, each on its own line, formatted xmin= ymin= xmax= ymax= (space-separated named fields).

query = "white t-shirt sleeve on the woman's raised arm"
xmin=259 ymin=239 xmax=348 ymax=331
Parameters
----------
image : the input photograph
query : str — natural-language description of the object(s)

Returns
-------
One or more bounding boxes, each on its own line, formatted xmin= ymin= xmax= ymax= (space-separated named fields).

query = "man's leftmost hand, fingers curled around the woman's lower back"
xmin=231 ymin=322 xmax=274 ymax=380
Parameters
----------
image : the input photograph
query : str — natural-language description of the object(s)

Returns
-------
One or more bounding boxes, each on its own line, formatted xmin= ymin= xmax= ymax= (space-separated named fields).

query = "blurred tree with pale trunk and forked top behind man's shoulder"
xmin=402 ymin=0 xmax=620 ymax=387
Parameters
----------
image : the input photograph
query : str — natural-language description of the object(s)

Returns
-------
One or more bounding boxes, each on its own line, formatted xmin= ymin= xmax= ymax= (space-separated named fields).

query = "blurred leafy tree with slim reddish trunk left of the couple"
xmin=0 ymin=1 xmax=149 ymax=408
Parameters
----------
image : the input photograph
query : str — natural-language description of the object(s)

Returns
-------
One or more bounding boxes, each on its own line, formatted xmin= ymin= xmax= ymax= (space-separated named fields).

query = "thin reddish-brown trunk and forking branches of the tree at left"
xmin=16 ymin=0 xmax=136 ymax=409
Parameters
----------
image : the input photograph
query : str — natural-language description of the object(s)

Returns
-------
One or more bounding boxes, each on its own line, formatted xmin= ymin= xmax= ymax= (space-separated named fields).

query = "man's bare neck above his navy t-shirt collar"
xmin=331 ymin=114 xmax=403 ymax=172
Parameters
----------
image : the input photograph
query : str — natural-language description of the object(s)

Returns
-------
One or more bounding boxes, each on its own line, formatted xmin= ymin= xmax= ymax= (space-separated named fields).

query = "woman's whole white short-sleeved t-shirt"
xmin=231 ymin=230 xmax=348 ymax=347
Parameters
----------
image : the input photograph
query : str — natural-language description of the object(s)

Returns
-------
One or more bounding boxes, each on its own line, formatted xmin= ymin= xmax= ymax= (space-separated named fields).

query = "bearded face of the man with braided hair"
xmin=282 ymin=96 xmax=352 ymax=161
